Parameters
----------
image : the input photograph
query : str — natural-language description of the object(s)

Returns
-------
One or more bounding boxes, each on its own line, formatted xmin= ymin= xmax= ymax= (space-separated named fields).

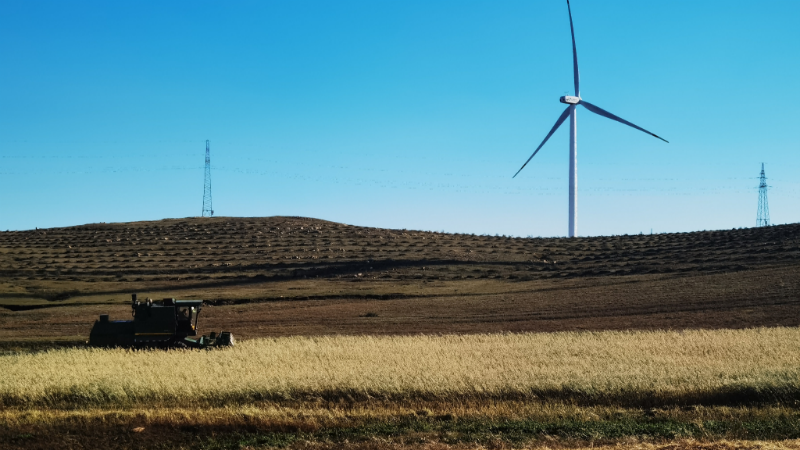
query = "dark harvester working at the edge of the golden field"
xmin=88 ymin=294 xmax=234 ymax=348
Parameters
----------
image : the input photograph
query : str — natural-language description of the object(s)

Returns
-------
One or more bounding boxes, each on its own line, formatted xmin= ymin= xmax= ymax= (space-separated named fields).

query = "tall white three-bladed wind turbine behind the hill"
xmin=512 ymin=0 xmax=669 ymax=237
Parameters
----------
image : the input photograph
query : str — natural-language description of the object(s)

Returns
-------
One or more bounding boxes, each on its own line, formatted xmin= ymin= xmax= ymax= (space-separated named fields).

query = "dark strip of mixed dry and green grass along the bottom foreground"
xmin=0 ymin=401 xmax=800 ymax=450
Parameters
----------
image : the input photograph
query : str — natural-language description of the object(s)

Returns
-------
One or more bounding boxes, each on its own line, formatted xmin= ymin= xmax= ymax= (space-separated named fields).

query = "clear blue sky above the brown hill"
xmin=0 ymin=0 xmax=800 ymax=236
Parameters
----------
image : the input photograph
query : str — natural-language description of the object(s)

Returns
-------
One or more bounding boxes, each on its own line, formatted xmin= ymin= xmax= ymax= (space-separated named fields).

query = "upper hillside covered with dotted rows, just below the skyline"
xmin=0 ymin=217 xmax=800 ymax=282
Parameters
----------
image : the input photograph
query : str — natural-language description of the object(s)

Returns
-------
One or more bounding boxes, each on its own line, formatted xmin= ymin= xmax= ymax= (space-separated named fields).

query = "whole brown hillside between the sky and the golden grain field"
xmin=0 ymin=217 xmax=800 ymax=342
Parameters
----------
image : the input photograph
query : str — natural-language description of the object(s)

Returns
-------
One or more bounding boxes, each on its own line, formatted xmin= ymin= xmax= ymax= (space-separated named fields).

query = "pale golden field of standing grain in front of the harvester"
xmin=6 ymin=328 xmax=800 ymax=406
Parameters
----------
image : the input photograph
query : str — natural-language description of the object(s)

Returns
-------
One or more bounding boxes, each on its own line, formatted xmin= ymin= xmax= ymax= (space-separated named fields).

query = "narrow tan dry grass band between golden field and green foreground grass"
xmin=0 ymin=399 xmax=800 ymax=432
